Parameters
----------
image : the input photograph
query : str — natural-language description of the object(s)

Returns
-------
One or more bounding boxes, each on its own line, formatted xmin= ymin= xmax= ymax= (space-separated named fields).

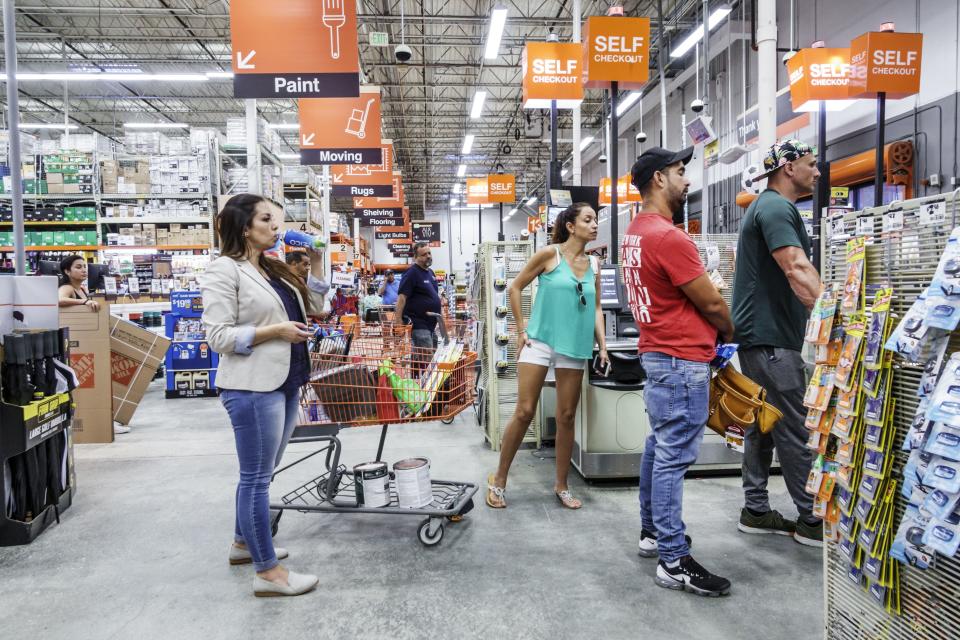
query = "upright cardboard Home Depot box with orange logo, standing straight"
xmin=60 ymin=303 xmax=113 ymax=444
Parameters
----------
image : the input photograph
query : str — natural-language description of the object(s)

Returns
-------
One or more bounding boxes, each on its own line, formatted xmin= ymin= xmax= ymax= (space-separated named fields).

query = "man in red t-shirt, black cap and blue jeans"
xmin=621 ymin=147 xmax=733 ymax=596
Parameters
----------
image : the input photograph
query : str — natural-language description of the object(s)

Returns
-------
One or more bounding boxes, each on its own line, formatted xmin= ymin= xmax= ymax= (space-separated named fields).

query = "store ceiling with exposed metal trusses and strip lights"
xmin=4 ymin=0 xmax=702 ymax=217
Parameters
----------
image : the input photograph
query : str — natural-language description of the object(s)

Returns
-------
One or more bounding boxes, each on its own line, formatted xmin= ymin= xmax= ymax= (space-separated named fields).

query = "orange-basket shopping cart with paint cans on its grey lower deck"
xmin=270 ymin=322 xmax=477 ymax=546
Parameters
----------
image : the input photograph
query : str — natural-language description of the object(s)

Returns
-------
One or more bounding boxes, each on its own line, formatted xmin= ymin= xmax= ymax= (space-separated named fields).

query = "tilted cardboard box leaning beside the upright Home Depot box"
xmin=110 ymin=316 xmax=170 ymax=424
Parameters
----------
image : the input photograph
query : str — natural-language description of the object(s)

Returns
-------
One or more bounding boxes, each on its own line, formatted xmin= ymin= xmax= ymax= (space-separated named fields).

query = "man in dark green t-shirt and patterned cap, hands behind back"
xmin=733 ymin=140 xmax=823 ymax=546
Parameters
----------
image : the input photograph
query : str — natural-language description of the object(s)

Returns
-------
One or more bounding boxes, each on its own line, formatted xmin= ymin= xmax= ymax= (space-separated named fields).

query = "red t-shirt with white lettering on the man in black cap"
xmin=620 ymin=213 xmax=717 ymax=362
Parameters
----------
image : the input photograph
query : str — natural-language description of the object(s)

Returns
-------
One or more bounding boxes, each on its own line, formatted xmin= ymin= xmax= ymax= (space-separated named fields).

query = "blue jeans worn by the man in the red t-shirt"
xmin=640 ymin=353 xmax=710 ymax=562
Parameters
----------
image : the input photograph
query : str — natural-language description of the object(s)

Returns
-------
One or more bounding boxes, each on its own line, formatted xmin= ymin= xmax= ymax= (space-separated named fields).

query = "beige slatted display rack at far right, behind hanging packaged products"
xmin=821 ymin=192 xmax=960 ymax=640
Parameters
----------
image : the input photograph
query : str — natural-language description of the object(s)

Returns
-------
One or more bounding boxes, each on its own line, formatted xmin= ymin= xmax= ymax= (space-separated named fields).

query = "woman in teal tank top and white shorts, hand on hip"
xmin=486 ymin=202 xmax=607 ymax=509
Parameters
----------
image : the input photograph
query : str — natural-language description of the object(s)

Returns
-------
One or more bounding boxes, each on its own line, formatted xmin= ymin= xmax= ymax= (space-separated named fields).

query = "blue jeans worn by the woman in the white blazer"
xmin=220 ymin=389 xmax=300 ymax=572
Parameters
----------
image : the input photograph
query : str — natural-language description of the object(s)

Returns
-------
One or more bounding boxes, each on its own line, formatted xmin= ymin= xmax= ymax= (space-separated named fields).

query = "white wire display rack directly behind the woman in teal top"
xmin=473 ymin=241 xmax=540 ymax=451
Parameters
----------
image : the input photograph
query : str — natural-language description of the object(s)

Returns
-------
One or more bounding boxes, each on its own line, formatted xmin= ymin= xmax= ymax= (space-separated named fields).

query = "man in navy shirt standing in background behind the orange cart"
xmin=395 ymin=242 xmax=440 ymax=349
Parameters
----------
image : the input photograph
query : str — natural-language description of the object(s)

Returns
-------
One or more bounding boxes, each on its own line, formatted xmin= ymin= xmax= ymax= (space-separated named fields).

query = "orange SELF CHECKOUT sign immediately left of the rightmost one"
xmin=787 ymin=48 xmax=850 ymax=112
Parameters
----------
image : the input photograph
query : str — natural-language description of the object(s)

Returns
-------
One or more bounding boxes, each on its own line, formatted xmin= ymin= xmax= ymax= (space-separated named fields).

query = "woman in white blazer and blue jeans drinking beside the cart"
xmin=200 ymin=194 xmax=329 ymax=596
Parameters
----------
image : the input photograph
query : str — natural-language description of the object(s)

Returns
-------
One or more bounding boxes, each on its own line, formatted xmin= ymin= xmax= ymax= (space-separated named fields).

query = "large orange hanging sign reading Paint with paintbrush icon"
xmin=230 ymin=0 xmax=360 ymax=98
